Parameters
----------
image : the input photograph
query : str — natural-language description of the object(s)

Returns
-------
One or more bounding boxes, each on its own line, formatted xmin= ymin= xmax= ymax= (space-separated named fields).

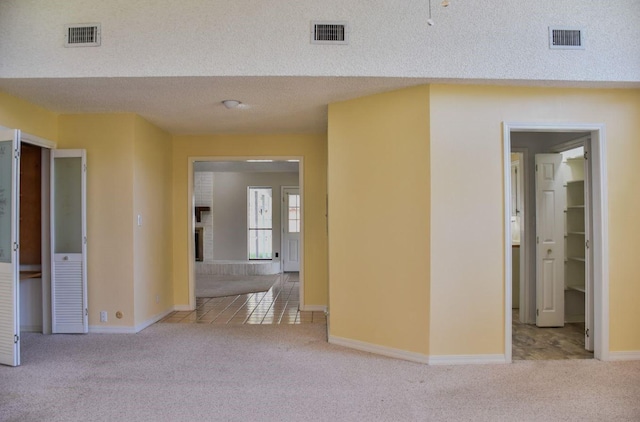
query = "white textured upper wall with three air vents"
xmin=0 ymin=0 xmax=640 ymax=83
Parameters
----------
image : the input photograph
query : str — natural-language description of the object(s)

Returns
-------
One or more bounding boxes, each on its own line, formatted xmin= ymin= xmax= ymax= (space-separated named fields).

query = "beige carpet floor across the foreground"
xmin=0 ymin=324 xmax=640 ymax=422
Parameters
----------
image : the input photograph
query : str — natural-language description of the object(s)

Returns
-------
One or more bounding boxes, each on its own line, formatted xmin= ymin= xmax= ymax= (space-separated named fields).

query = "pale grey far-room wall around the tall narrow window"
xmin=211 ymin=172 xmax=298 ymax=260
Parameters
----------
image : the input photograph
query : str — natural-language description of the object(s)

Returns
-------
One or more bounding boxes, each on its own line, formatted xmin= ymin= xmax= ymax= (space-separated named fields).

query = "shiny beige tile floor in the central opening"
xmin=160 ymin=273 xmax=327 ymax=325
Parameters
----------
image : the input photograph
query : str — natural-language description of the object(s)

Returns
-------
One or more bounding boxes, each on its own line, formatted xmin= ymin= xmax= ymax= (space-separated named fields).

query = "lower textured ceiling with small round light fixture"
xmin=0 ymin=77 xmax=436 ymax=134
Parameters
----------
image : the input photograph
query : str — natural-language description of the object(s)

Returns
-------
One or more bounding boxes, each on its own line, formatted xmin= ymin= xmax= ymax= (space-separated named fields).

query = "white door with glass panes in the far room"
xmin=282 ymin=188 xmax=302 ymax=272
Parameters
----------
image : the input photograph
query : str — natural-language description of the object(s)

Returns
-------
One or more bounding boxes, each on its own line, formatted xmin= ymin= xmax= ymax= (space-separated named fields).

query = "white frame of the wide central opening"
xmin=186 ymin=155 xmax=305 ymax=310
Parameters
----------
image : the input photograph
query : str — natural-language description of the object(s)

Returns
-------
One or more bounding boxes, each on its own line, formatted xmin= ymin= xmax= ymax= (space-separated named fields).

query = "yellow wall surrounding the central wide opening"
xmin=173 ymin=134 xmax=327 ymax=306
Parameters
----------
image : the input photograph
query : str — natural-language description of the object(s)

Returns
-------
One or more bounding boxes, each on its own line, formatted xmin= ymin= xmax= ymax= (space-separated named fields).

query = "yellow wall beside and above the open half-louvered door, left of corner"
xmin=58 ymin=114 xmax=136 ymax=326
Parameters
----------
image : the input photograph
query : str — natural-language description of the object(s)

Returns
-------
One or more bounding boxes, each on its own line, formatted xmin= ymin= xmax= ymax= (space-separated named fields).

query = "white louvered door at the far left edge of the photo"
xmin=0 ymin=130 xmax=20 ymax=366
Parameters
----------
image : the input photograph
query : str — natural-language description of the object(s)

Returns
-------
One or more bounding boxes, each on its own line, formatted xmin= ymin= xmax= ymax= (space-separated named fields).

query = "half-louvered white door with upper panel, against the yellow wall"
xmin=51 ymin=150 xmax=89 ymax=333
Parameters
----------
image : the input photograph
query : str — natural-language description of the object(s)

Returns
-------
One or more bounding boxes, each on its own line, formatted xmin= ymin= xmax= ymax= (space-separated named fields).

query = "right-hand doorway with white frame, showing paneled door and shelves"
xmin=504 ymin=124 xmax=608 ymax=361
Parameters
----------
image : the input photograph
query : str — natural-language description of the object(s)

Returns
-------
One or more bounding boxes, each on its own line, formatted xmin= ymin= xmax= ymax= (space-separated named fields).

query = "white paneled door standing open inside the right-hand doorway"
xmin=536 ymin=154 xmax=566 ymax=327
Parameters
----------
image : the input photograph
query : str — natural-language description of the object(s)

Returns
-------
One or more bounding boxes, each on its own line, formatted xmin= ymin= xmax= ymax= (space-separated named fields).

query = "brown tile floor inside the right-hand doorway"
xmin=512 ymin=309 xmax=593 ymax=360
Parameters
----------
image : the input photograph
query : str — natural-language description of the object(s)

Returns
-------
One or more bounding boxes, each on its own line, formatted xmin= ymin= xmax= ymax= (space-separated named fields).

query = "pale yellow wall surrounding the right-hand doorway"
xmin=428 ymin=85 xmax=640 ymax=355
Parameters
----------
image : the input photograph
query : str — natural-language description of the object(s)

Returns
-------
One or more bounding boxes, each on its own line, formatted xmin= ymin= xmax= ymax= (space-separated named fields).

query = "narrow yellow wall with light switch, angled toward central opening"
xmin=130 ymin=116 xmax=173 ymax=325
